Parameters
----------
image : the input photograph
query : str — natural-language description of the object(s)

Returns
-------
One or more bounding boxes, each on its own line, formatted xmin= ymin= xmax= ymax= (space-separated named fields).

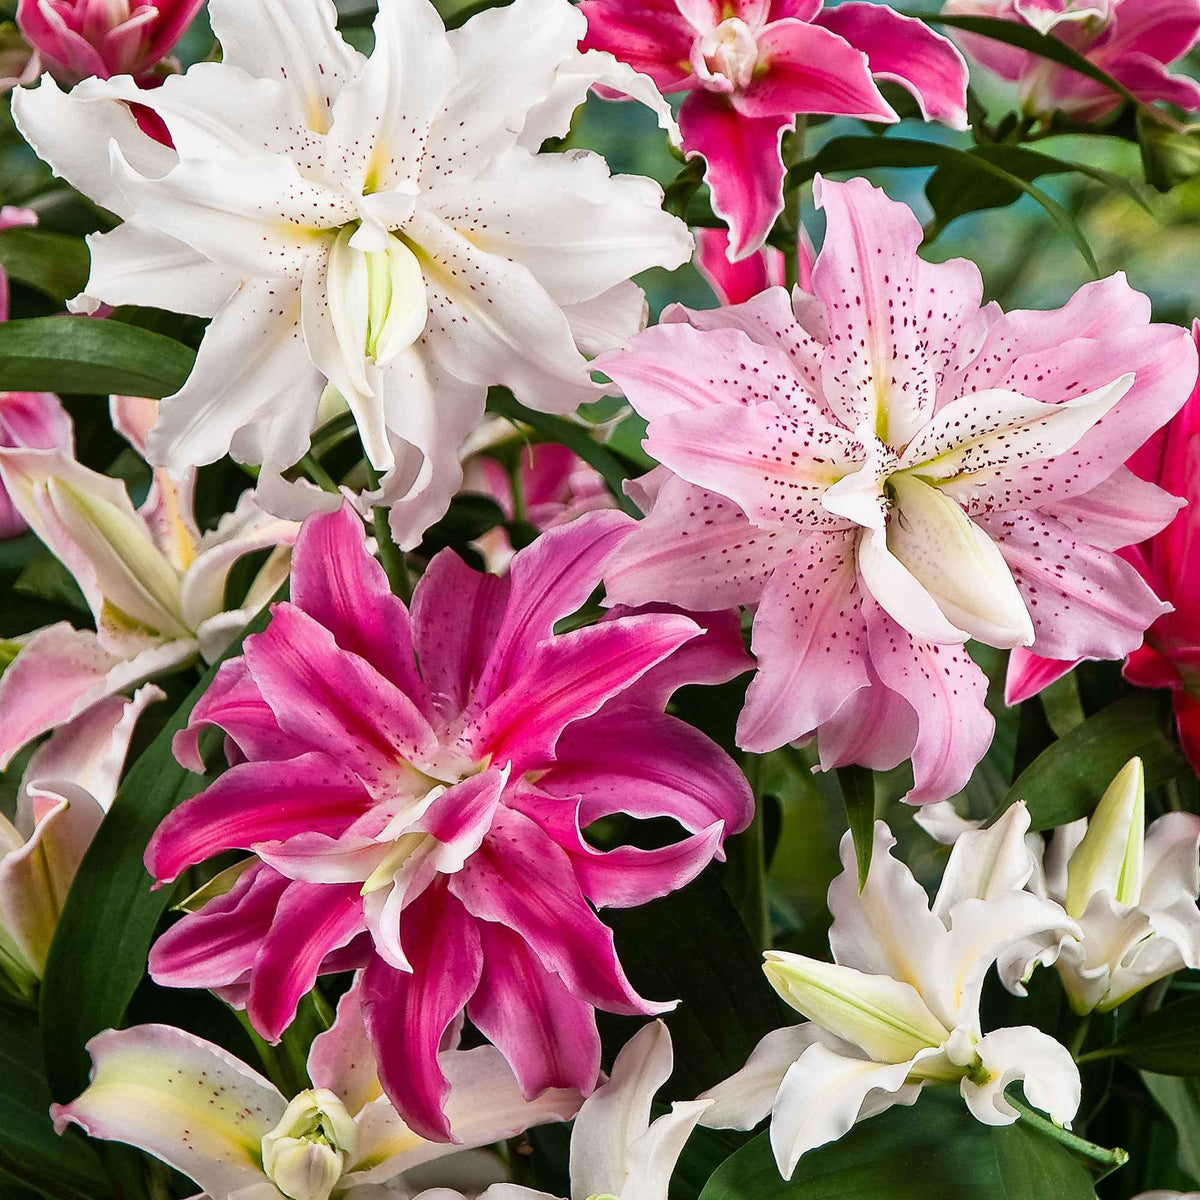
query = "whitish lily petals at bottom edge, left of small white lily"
xmin=403 ymin=1021 xmax=709 ymax=1200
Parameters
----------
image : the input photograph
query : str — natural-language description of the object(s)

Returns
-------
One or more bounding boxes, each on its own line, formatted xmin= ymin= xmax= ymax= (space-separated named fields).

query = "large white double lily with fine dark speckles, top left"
xmin=13 ymin=0 xmax=691 ymax=547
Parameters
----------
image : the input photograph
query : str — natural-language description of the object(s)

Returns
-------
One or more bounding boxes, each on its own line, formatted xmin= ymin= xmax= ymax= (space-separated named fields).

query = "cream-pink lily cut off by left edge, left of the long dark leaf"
xmin=0 ymin=684 xmax=164 ymax=997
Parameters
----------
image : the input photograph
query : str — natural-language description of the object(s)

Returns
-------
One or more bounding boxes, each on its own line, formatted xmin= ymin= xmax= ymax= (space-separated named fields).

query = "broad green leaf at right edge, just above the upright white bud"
xmin=1001 ymin=691 xmax=1188 ymax=829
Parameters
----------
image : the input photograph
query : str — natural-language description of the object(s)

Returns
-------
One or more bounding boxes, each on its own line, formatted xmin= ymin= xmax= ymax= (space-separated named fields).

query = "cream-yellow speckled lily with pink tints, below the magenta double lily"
xmin=52 ymin=982 xmax=581 ymax=1200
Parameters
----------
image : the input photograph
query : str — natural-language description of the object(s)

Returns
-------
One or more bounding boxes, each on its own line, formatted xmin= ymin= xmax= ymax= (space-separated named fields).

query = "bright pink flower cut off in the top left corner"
xmin=17 ymin=0 xmax=204 ymax=84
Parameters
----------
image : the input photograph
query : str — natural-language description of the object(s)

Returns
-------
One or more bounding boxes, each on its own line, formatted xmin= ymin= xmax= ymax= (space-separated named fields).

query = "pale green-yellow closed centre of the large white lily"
xmin=328 ymin=226 xmax=430 ymax=394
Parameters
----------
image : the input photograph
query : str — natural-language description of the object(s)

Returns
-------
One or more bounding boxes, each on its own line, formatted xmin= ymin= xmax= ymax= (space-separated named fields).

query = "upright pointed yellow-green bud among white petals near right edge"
xmin=1067 ymin=758 xmax=1146 ymax=918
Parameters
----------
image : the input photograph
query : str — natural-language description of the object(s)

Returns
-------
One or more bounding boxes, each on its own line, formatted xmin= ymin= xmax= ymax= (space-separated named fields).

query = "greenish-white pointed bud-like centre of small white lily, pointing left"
xmin=763 ymin=950 xmax=950 ymax=1063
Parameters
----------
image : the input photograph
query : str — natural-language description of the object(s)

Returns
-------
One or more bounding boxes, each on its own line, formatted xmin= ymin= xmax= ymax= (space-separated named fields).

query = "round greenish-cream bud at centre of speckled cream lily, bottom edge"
xmin=263 ymin=1087 xmax=359 ymax=1200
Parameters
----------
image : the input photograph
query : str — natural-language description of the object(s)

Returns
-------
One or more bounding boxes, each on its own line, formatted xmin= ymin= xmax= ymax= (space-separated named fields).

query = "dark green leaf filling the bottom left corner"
xmin=0 ymin=1008 xmax=112 ymax=1200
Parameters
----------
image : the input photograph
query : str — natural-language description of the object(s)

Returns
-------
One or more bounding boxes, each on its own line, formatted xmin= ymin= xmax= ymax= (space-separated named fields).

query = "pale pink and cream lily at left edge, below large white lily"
xmin=0 ymin=396 xmax=299 ymax=769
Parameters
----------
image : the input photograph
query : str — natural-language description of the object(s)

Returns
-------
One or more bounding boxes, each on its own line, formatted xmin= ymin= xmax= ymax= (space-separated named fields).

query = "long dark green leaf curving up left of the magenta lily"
xmin=41 ymin=584 xmax=286 ymax=1103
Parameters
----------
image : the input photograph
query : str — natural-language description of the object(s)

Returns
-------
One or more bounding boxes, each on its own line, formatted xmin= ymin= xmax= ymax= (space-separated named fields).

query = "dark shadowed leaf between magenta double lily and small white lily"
xmin=604 ymin=871 xmax=781 ymax=1099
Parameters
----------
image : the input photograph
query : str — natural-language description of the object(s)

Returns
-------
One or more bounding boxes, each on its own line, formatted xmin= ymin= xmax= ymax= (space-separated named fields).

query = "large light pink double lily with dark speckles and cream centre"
xmin=598 ymin=178 xmax=1196 ymax=804
